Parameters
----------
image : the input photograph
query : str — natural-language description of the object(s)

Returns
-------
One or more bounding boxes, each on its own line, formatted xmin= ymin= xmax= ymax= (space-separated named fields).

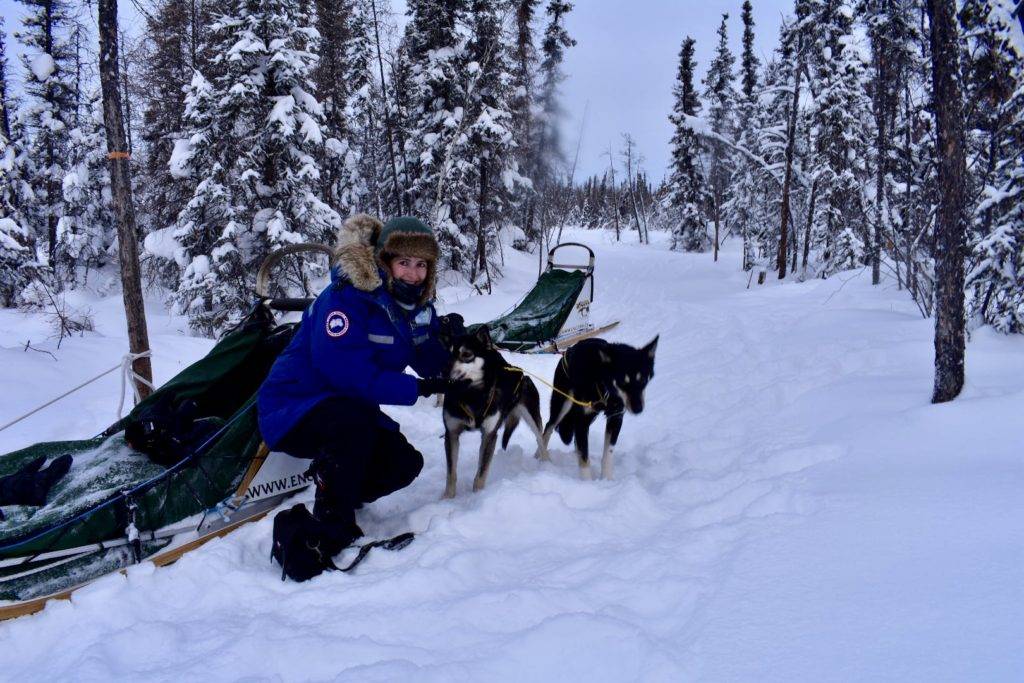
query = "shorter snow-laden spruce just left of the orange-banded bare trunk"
xmin=56 ymin=92 xmax=117 ymax=287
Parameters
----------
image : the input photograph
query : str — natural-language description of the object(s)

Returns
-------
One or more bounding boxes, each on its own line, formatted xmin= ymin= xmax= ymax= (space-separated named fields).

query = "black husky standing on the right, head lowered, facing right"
xmin=544 ymin=337 xmax=657 ymax=479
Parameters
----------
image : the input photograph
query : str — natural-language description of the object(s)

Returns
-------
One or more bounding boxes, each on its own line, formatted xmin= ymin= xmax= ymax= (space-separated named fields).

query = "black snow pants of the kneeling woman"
xmin=278 ymin=396 xmax=423 ymax=531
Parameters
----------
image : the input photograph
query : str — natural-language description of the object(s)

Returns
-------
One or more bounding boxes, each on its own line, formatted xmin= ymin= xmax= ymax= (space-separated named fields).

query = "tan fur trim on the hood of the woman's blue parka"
xmin=333 ymin=213 xmax=437 ymax=305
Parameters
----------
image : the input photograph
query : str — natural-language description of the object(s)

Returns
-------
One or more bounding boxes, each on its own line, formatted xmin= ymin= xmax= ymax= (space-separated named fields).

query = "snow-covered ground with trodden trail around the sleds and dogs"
xmin=0 ymin=231 xmax=1024 ymax=681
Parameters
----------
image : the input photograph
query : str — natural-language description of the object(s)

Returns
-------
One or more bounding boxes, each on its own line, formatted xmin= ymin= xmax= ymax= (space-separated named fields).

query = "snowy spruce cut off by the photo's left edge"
xmin=0 ymin=18 xmax=34 ymax=308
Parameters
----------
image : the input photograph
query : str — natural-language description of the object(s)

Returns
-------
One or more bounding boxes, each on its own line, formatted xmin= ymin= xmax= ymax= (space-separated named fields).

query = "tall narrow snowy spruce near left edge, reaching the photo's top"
xmin=15 ymin=0 xmax=76 ymax=266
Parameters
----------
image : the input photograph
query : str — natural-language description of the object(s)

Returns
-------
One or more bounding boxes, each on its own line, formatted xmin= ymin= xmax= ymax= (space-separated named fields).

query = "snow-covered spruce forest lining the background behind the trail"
xmin=0 ymin=0 xmax=1024 ymax=344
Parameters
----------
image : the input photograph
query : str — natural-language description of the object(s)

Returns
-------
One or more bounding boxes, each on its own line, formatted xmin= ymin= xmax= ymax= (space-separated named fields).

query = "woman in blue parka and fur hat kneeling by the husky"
xmin=258 ymin=214 xmax=450 ymax=555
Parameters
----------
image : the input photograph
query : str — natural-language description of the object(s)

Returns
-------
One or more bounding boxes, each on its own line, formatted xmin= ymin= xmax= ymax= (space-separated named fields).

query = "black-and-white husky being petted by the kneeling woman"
xmin=443 ymin=326 xmax=548 ymax=498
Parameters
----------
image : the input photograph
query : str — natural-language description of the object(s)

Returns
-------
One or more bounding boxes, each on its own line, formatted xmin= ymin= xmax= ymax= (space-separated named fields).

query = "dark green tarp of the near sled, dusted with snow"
xmin=0 ymin=310 xmax=294 ymax=565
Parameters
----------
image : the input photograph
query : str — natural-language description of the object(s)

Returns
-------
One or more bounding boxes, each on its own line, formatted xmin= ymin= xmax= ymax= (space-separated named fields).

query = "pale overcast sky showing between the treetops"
xmin=0 ymin=0 xmax=793 ymax=182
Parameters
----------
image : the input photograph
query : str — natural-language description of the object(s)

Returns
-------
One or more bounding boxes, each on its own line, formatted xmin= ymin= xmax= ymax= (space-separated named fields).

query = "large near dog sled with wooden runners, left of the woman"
xmin=0 ymin=245 xmax=330 ymax=620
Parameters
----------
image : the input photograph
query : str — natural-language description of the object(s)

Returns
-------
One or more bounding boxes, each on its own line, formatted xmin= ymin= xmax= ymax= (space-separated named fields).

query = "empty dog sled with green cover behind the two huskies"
xmin=471 ymin=242 xmax=618 ymax=353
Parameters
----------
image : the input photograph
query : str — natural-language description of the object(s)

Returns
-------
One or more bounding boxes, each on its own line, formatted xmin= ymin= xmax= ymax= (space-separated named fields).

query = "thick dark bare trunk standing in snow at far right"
xmin=928 ymin=0 xmax=967 ymax=403
